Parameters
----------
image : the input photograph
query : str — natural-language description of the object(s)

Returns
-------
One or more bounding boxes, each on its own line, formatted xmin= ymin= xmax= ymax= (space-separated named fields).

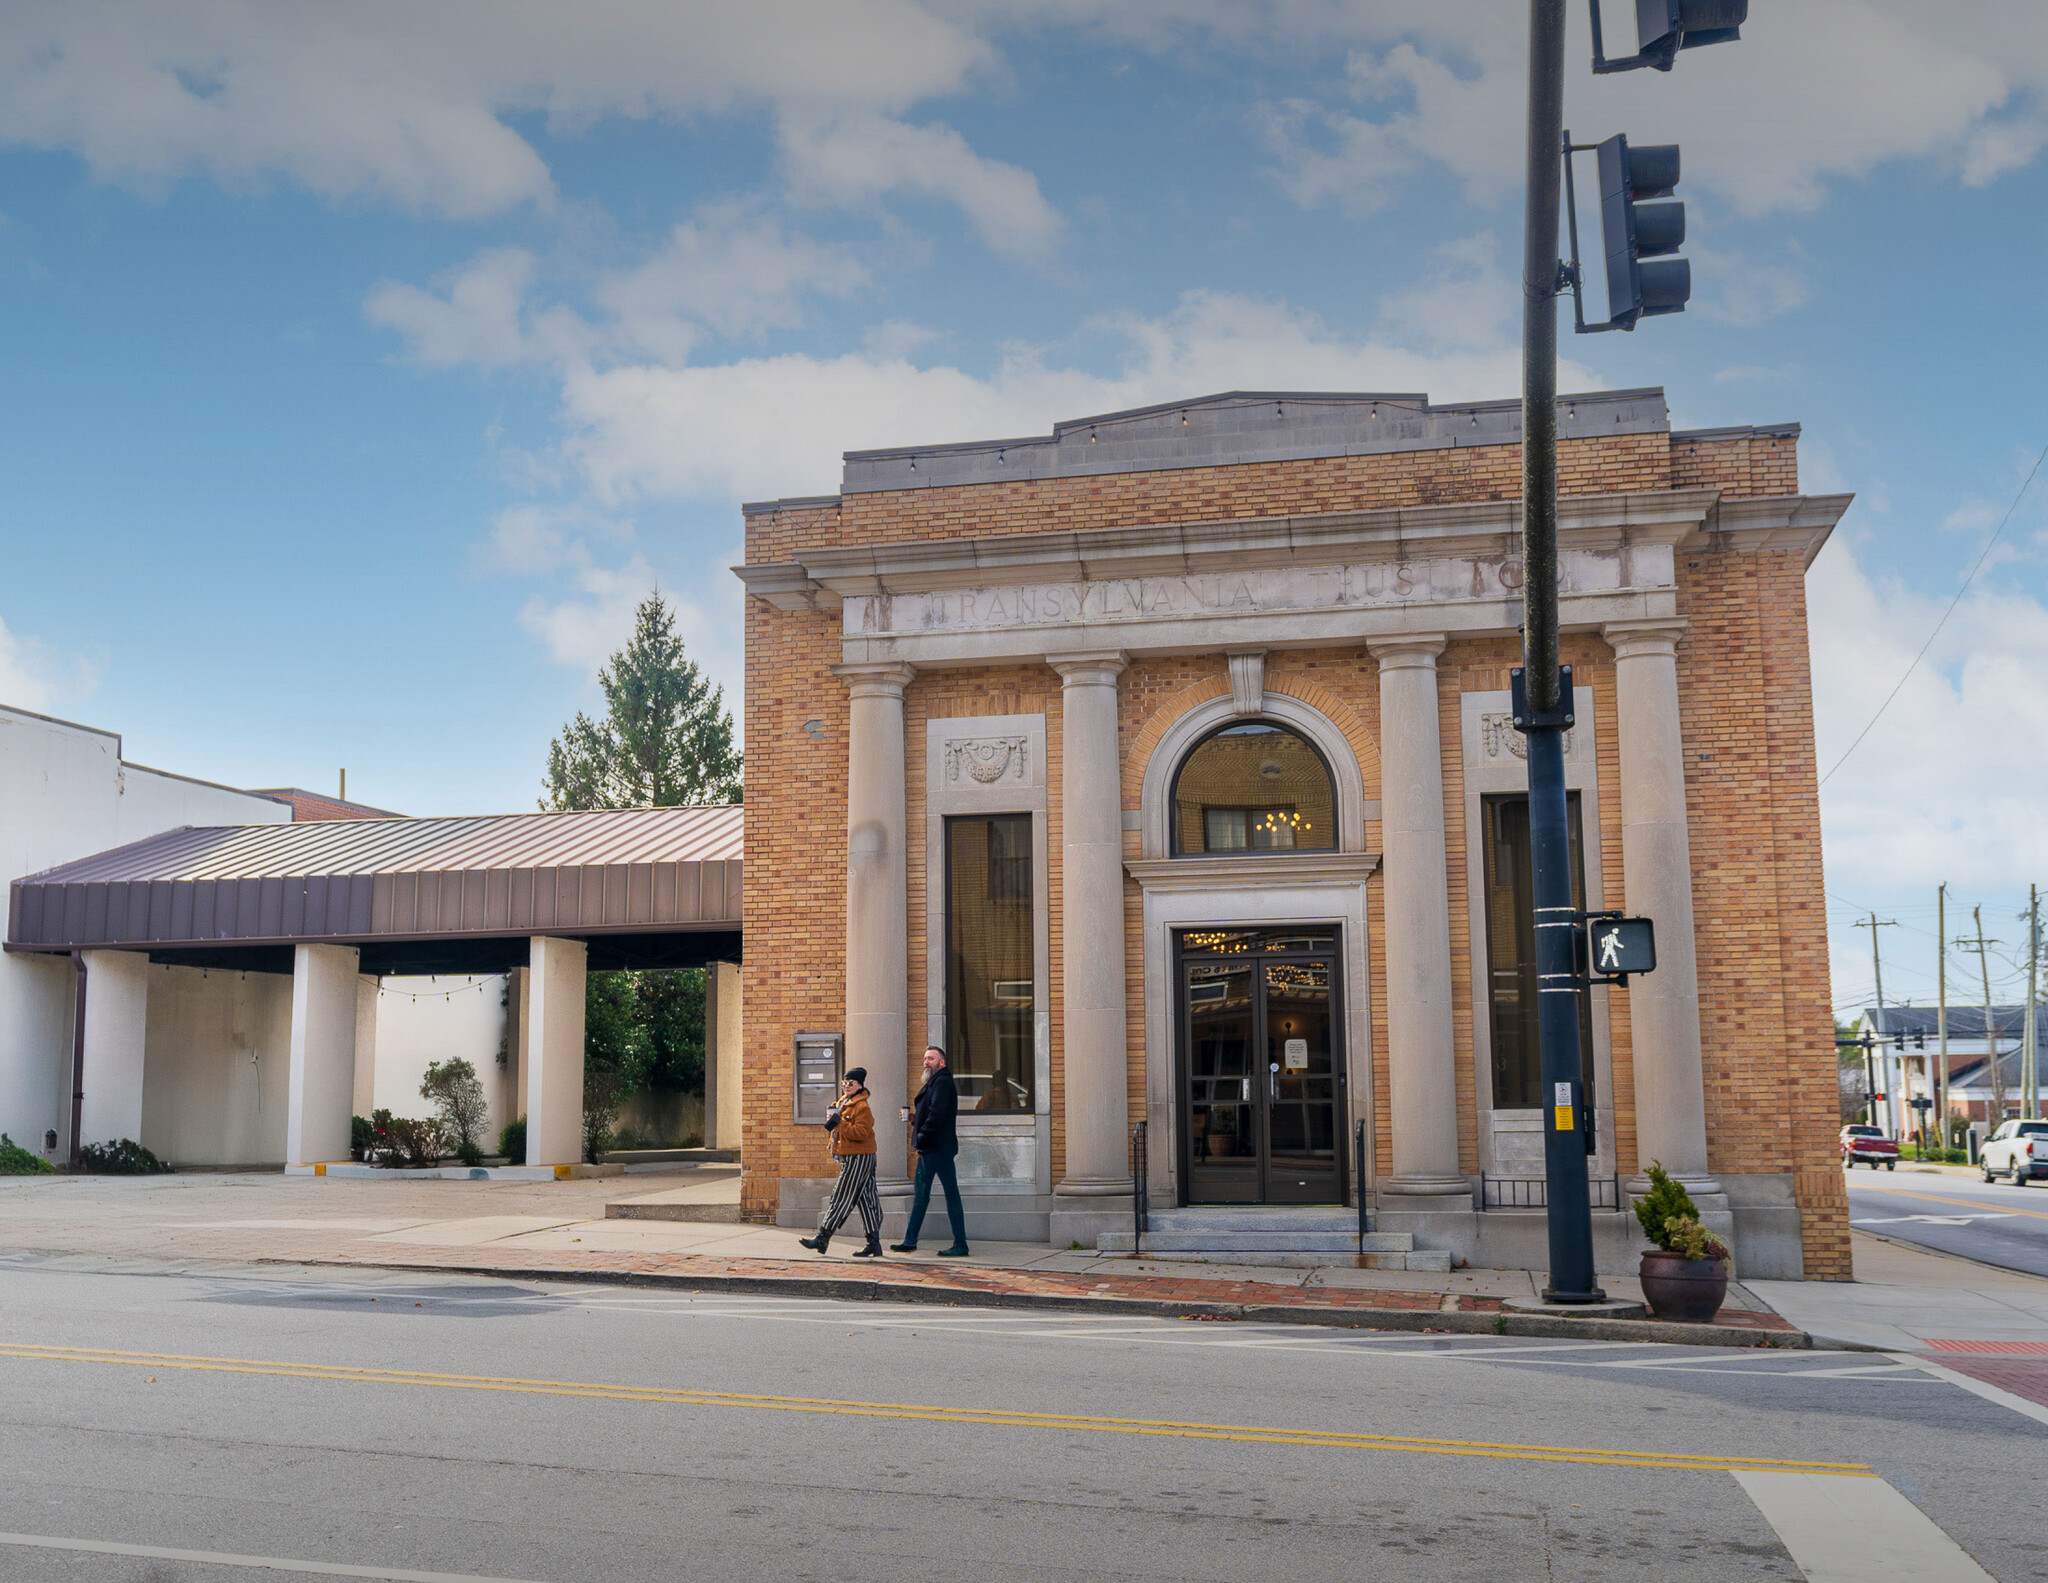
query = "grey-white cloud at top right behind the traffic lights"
xmin=1264 ymin=0 xmax=2048 ymax=215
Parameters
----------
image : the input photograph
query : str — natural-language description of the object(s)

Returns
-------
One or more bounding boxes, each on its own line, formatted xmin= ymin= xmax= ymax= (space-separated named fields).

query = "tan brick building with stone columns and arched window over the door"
xmin=739 ymin=389 xmax=1849 ymax=1278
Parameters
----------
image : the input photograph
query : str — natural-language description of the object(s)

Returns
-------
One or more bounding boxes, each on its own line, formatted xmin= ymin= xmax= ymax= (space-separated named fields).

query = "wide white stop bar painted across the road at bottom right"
xmin=1735 ymin=1470 xmax=1997 ymax=1583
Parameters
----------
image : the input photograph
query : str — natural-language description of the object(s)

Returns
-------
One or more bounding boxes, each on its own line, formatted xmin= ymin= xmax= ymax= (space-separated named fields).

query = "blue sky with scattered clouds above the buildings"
xmin=0 ymin=0 xmax=2048 ymax=1006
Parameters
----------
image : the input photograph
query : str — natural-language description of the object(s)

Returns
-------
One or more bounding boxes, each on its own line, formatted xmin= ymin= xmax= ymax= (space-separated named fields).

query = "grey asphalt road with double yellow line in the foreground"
xmin=0 ymin=1261 xmax=2048 ymax=1583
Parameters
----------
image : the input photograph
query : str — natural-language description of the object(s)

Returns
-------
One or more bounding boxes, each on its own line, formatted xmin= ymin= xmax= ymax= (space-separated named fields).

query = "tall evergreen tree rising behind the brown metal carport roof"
xmin=541 ymin=592 xmax=741 ymax=811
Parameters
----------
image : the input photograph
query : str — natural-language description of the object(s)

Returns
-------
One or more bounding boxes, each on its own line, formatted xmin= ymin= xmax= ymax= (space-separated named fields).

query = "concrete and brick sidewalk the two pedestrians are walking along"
xmin=0 ymin=1167 xmax=1806 ymax=1345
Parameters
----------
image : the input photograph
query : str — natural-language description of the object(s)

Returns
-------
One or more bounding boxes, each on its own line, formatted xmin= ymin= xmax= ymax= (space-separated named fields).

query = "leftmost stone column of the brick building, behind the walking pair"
xmin=831 ymin=664 xmax=918 ymax=1194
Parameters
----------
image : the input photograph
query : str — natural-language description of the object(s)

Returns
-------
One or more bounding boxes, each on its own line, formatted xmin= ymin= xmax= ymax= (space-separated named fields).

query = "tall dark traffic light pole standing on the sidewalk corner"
xmin=1516 ymin=0 xmax=1606 ymax=1302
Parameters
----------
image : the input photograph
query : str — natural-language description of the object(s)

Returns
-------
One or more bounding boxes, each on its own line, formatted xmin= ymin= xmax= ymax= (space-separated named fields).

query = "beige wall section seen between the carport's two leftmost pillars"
xmin=141 ymin=967 xmax=291 ymax=1165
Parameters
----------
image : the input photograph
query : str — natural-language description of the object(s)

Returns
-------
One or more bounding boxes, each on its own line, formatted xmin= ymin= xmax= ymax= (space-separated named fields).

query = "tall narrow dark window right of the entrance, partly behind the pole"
xmin=1483 ymin=793 xmax=1593 ymax=1110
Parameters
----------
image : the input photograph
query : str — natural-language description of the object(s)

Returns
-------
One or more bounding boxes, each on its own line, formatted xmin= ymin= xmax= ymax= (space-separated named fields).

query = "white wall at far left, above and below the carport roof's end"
xmin=0 ymin=702 xmax=291 ymax=1155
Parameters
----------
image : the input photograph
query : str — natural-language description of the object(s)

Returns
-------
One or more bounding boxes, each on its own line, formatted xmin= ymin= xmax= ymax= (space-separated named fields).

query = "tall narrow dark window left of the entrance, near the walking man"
xmin=946 ymin=813 xmax=1036 ymax=1114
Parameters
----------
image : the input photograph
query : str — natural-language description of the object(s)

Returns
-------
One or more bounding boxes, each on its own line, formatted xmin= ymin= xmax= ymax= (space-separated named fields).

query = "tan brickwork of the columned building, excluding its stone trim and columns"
xmin=743 ymin=401 xmax=1849 ymax=1280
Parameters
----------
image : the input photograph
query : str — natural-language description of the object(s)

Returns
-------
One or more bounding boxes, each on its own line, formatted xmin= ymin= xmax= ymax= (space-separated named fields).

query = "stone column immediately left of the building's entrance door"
xmin=1047 ymin=649 xmax=1130 ymax=1245
